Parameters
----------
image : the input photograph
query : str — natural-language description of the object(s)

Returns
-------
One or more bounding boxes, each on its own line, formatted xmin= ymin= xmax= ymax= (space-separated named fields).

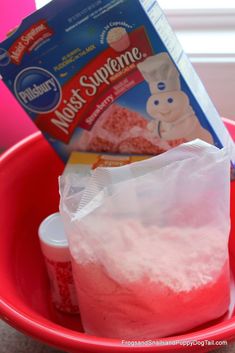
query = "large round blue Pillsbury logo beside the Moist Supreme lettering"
xmin=14 ymin=67 xmax=62 ymax=114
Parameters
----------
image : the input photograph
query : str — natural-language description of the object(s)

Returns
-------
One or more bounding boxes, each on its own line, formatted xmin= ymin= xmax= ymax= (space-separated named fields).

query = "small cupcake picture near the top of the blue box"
xmin=107 ymin=27 xmax=130 ymax=52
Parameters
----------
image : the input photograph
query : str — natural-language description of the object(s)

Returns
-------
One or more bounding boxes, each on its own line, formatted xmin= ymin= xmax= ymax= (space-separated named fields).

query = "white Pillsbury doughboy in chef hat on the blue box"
xmin=138 ymin=53 xmax=213 ymax=144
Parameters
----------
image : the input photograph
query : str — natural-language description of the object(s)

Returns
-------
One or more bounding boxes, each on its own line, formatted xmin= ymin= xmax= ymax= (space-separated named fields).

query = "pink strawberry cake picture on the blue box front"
xmin=76 ymin=104 xmax=181 ymax=155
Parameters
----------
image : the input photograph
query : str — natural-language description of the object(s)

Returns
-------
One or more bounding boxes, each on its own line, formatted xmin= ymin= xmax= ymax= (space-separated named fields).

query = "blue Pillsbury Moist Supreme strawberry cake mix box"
xmin=0 ymin=0 xmax=234 ymax=161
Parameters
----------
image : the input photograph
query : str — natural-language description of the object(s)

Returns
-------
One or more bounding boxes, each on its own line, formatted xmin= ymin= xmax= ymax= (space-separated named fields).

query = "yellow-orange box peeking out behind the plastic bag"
xmin=63 ymin=152 xmax=149 ymax=177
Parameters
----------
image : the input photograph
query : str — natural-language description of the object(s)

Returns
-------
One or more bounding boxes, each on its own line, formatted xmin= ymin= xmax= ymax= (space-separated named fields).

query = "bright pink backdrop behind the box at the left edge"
xmin=0 ymin=0 xmax=36 ymax=149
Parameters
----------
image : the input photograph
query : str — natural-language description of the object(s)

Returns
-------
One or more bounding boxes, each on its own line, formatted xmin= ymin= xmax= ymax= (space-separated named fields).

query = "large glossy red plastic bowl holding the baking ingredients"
xmin=0 ymin=120 xmax=235 ymax=353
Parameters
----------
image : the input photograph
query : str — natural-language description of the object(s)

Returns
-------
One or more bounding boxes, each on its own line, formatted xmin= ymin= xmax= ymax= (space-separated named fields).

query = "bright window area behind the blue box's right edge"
xmin=154 ymin=0 xmax=235 ymax=120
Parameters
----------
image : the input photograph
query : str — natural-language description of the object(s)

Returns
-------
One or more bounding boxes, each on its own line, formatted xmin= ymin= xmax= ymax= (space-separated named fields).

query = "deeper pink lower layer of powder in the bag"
xmin=74 ymin=264 xmax=229 ymax=339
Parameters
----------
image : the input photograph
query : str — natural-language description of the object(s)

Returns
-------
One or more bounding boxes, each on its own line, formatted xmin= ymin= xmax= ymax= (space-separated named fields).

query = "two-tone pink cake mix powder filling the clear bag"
xmin=70 ymin=217 xmax=230 ymax=339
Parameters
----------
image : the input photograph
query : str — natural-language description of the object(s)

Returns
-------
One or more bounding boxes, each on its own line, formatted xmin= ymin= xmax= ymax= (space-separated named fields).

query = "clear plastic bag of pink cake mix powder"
xmin=60 ymin=140 xmax=230 ymax=339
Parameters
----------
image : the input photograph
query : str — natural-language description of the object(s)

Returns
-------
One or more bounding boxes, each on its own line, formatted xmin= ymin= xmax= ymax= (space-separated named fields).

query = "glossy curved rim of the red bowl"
xmin=0 ymin=125 xmax=235 ymax=352
